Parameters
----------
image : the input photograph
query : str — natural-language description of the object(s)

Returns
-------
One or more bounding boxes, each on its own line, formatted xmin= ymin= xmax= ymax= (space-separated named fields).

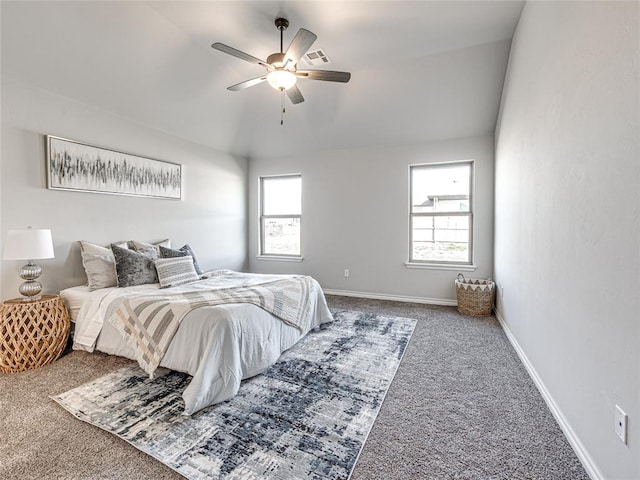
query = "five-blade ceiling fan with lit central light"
xmin=211 ymin=18 xmax=351 ymax=112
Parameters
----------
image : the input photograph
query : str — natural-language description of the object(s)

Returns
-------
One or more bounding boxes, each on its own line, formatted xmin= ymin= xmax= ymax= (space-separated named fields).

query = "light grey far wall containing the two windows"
xmin=249 ymin=136 xmax=493 ymax=303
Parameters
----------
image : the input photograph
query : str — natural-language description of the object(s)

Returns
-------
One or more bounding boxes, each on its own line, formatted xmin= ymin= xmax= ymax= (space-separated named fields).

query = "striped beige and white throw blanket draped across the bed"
xmin=107 ymin=276 xmax=314 ymax=378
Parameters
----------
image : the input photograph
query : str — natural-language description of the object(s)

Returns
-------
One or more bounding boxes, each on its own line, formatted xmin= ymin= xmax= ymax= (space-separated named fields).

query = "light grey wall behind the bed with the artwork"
xmin=0 ymin=78 xmax=247 ymax=299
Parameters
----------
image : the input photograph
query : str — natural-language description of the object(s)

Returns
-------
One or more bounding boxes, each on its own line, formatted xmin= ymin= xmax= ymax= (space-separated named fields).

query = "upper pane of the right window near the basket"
xmin=411 ymin=163 xmax=471 ymax=213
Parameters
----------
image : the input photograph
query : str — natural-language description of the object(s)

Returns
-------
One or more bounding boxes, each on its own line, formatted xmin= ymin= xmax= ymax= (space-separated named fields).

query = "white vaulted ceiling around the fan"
xmin=0 ymin=0 xmax=523 ymax=157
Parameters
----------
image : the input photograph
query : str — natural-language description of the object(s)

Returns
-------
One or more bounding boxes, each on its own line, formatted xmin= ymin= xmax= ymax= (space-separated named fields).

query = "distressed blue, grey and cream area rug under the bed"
xmin=52 ymin=311 xmax=416 ymax=480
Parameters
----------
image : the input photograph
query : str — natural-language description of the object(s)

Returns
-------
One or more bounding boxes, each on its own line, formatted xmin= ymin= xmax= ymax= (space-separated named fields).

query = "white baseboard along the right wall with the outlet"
xmin=494 ymin=308 xmax=605 ymax=480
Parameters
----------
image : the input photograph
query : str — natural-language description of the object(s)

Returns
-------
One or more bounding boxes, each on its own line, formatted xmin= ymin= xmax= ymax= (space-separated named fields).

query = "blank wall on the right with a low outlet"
xmin=495 ymin=2 xmax=640 ymax=480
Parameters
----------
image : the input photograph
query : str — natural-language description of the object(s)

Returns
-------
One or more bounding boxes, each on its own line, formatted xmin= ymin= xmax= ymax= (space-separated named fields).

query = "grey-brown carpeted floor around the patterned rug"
xmin=0 ymin=296 xmax=589 ymax=480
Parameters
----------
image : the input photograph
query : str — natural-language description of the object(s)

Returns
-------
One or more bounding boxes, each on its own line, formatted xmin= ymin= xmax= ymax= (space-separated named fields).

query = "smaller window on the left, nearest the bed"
xmin=260 ymin=175 xmax=302 ymax=257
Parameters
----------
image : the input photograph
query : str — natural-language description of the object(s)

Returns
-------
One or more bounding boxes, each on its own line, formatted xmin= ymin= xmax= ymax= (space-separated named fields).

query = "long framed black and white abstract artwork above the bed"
xmin=47 ymin=135 xmax=182 ymax=199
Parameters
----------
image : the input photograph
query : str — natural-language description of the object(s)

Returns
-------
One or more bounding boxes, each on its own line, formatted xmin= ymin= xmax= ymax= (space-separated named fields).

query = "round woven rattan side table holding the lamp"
xmin=0 ymin=295 xmax=71 ymax=373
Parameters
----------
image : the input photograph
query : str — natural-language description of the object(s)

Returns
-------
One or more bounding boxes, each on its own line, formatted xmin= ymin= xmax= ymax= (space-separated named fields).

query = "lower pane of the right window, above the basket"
xmin=411 ymin=216 xmax=470 ymax=262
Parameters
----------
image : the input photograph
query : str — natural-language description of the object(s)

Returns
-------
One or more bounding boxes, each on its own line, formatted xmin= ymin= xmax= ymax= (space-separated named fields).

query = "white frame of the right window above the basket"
xmin=405 ymin=160 xmax=477 ymax=271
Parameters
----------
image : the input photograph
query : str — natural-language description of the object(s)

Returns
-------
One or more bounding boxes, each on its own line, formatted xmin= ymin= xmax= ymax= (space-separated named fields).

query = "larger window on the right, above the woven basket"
xmin=409 ymin=161 xmax=473 ymax=265
